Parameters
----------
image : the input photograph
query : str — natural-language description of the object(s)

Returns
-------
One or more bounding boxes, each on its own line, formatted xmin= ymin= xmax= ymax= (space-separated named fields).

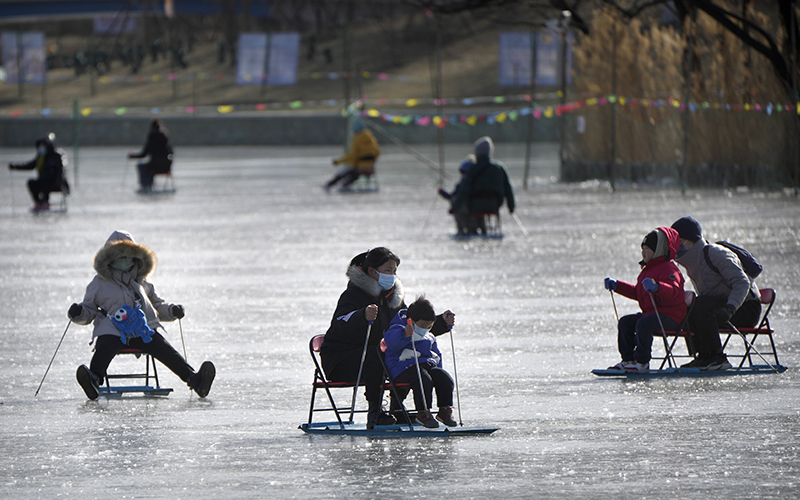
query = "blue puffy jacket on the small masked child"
xmin=383 ymin=309 xmax=442 ymax=379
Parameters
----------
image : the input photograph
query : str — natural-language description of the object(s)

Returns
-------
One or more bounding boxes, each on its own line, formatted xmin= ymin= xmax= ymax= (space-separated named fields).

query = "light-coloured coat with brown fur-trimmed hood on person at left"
xmin=73 ymin=231 xmax=180 ymax=337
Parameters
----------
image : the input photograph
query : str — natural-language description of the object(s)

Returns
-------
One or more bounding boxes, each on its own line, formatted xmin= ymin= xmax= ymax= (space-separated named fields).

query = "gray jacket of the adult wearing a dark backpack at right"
xmin=675 ymin=238 xmax=760 ymax=309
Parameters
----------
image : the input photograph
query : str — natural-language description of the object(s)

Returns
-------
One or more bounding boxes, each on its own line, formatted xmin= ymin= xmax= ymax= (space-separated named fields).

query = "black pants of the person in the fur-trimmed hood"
xmin=89 ymin=332 xmax=195 ymax=383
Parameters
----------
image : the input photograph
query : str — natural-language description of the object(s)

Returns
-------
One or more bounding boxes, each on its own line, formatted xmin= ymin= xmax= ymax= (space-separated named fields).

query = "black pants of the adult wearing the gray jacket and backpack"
xmin=689 ymin=295 xmax=761 ymax=355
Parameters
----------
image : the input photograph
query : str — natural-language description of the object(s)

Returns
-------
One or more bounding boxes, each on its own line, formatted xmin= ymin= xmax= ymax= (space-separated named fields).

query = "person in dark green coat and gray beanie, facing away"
xmin=451 ymin=136 xmax=516 ymax=235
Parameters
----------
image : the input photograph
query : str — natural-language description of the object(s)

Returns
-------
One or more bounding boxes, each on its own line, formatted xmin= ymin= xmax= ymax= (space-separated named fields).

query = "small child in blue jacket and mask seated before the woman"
xmin=383 ymin=297 xmax=457 ymax=428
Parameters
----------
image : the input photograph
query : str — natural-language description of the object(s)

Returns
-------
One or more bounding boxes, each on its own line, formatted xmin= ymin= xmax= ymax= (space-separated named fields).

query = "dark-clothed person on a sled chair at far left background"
xmin=8 ymin=134 xmax=69 ymax=213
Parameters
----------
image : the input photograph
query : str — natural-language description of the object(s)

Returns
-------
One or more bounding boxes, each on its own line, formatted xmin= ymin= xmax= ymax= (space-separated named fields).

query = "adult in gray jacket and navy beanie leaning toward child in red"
xmin=672 ymin=217 xmax=761 ymax=371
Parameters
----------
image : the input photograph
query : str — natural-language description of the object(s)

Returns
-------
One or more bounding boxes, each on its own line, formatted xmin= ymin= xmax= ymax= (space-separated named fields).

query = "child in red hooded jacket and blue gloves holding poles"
xmin=605 ymin=227 xmax=686 ymax=373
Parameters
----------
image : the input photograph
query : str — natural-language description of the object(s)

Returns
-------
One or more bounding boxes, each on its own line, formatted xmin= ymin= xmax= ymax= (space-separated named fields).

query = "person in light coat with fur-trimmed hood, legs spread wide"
xmin=67 ymin=231 xmax=216 ymax=399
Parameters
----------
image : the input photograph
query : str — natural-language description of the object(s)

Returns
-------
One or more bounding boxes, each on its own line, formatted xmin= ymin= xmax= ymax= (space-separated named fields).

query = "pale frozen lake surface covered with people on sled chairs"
xmin=0 ymin=144 xmax=800 ymax=499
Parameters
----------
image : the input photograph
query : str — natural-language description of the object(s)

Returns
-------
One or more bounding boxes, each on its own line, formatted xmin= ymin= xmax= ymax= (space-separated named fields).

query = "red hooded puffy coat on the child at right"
xmin=616 ymin=227 xmax=686 ymax=323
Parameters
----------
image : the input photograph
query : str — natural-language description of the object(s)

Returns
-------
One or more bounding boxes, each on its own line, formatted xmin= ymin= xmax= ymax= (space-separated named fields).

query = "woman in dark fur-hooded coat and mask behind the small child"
xmin=320 ymin=247 xmax=456 ymax=429
